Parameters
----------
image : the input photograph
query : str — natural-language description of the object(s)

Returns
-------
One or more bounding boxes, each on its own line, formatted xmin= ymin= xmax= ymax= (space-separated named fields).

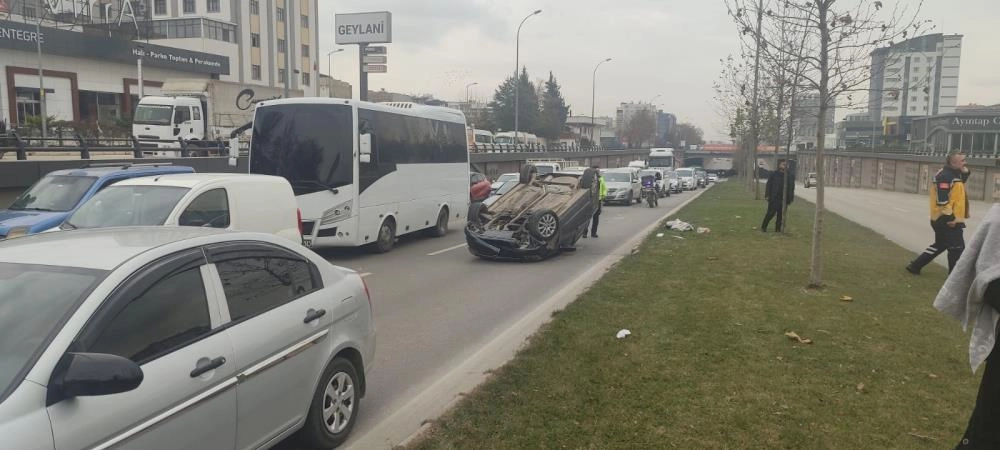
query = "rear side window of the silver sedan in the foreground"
xmin=215 ymin=252 xmax=320 ymax=322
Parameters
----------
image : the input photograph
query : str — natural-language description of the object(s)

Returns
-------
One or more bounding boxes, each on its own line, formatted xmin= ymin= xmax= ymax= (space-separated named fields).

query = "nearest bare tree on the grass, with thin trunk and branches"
xmin=725 ymin=0 xmax=927 ymax=288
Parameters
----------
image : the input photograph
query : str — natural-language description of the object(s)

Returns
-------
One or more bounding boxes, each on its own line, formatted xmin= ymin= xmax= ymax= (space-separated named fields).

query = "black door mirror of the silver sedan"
xmin=53 ymin=352 xmax=143 ymax=398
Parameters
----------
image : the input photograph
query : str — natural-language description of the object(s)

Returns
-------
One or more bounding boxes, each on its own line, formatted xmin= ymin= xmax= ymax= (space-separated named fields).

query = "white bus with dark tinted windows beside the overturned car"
xmin=250 ymin=98 xmax=469 ymax=253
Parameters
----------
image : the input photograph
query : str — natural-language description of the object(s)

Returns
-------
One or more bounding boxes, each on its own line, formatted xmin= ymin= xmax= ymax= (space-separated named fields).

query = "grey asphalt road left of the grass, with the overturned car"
xmin=278 ymin=185 xmax=704 ymax=449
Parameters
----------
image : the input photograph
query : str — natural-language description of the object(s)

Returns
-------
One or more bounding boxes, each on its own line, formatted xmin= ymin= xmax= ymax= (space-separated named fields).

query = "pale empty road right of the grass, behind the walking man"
xmin=795 ymin=186 xmax=992 ymax=269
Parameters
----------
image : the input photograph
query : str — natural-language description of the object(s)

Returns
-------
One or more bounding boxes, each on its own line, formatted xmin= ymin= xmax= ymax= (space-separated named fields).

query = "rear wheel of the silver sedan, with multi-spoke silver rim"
xmin=296 ymin=358 xmax=361 ymax=449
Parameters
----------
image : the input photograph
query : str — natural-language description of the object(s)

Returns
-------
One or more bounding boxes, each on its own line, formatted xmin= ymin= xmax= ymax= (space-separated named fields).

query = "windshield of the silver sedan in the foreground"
xmin=0 ymin=263 xmax=105 ymax=402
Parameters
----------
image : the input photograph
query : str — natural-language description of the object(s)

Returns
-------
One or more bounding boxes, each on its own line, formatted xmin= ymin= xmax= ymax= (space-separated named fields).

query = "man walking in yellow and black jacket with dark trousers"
xmin=906 ymin=153 xmax=969 ymax=275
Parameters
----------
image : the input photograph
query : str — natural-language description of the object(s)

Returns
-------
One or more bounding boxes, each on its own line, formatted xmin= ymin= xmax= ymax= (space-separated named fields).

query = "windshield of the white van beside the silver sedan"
xmin=63 ymin=186 xmax=189 ymax=229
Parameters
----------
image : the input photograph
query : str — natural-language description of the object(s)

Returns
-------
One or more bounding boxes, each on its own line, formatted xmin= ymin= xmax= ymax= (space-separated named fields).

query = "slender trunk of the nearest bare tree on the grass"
xmin=809 ymin=0 xmax=832 ymax=288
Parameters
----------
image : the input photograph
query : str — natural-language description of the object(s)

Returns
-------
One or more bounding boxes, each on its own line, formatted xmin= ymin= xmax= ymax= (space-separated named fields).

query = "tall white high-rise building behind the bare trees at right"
xmin=868 ymin=33 xmax=962 ymax=140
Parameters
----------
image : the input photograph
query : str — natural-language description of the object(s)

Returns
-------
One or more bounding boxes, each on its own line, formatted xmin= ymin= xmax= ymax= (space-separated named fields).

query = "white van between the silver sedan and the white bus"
xmin=60 ymin=173 xmax=302 ymax=243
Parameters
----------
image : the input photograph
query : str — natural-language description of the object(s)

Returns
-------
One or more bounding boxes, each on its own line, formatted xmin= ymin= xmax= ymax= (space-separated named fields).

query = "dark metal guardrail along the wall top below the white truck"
xmin=0 ymin=131 xmax=229 ymax=161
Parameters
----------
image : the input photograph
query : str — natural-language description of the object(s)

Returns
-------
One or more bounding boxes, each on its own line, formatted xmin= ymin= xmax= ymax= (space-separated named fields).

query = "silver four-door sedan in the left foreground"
xmin=0 ymin=227 xmax=375 ymax=450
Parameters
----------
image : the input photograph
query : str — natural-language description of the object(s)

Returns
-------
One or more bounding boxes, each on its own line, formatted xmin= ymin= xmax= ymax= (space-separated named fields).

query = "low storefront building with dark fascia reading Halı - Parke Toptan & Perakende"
xmin=0 ymin=0 xmax=232 ymax=127
